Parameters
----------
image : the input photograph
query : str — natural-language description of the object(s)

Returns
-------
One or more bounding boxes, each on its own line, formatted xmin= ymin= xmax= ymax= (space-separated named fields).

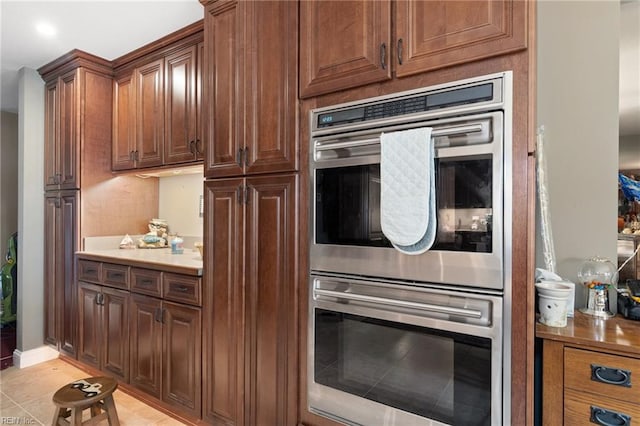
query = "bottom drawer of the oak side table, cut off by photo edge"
xmin=564 ymin=389 xmax=640 ymax=426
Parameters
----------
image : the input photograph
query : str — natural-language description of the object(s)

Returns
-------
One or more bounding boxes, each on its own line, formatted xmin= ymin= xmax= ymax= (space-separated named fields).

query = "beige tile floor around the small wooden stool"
xmin=0 ymin=359 xmax=184 ymax=426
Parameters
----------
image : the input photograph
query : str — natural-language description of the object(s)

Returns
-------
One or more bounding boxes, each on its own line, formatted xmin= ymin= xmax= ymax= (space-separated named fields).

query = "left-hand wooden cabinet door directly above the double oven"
xmin=300 ymin=0 xmax=392 ymax=98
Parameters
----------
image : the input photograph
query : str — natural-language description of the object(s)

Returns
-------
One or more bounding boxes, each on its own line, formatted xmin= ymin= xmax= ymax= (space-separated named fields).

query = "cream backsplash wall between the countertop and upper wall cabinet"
xmin=158 ymin=173 xmax=203 ymax=237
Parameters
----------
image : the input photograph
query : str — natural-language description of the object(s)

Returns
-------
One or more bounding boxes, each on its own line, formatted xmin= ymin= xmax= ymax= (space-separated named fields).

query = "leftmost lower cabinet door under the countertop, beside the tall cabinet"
xmin=78 ymin=281 xmax=103 ymax=369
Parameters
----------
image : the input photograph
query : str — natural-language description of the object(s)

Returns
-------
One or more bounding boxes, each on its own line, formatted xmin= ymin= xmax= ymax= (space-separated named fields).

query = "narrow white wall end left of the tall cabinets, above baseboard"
xmin=16 ymin=68 xmax=44 ymax=352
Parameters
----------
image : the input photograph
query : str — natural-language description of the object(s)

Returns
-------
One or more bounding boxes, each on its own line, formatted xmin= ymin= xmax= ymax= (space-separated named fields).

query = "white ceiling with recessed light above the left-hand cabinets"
xmin=0 ymin=0 xmax=204 ymax=113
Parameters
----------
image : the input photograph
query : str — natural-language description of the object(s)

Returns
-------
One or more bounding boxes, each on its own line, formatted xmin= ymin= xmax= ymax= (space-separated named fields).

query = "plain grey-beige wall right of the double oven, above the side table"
xmin=536 ymin=1 xmax=620 ymax=307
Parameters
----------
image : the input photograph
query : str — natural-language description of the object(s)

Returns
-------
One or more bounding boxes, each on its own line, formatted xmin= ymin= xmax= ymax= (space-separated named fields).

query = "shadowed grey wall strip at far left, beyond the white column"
xmin=0 ymin=111 xmax=18 ymax=255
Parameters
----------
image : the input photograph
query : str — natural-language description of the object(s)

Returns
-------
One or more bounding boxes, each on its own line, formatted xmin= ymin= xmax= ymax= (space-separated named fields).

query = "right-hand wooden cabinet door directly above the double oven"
xmin=395 ymin=0 xmax=527 ymax=77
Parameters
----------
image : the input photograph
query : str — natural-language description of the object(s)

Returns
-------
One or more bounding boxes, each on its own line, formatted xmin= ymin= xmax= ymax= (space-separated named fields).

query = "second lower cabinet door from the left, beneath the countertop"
xmin=100 ymin=287 xmax=129 ymax=382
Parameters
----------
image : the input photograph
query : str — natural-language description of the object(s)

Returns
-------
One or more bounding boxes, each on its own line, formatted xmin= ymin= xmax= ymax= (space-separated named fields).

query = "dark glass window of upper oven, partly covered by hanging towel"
xmin=315 ymin=159 xmax=493 ymax=253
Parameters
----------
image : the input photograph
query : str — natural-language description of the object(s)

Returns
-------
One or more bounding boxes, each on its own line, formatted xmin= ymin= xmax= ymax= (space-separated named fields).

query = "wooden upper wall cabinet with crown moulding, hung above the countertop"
xmin=112 ymin=22 xmax=203 ymax=170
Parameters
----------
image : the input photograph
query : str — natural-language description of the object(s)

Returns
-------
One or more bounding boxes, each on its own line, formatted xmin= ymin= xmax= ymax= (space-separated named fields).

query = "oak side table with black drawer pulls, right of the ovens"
xmin=536 ymin=311 xmax=640 ymax=425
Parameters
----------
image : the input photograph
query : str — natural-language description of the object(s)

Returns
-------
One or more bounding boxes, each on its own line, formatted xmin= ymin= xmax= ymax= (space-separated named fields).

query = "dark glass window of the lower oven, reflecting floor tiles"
xmin=314 ymin=308 xmax=491 ymax=426
